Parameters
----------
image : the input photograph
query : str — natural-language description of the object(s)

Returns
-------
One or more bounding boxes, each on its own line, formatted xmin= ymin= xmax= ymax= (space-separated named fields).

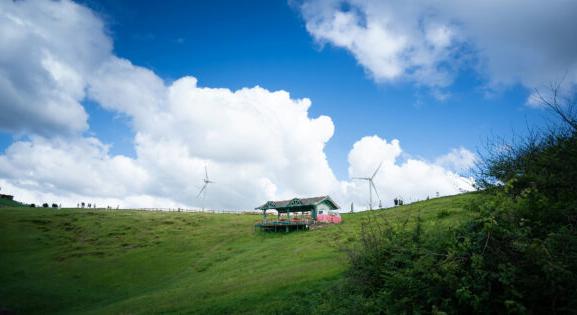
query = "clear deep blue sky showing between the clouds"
xmin=70 ymin=1 xmax=544 ymax=179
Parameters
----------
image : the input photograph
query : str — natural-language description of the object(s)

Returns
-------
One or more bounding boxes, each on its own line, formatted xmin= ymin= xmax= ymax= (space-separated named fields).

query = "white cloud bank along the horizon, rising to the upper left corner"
xmin=0 ymin=1 xmax=470 ymax=209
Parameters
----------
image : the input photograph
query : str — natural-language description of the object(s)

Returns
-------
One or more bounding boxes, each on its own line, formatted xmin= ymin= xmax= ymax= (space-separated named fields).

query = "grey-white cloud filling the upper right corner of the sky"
xmin=300 ymin=0 xmax=577 ymax=93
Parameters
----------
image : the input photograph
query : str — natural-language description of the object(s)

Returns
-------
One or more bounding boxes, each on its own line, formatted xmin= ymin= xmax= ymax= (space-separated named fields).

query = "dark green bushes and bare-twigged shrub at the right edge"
xmin=320 ymin=97 xmax=577 ymax=314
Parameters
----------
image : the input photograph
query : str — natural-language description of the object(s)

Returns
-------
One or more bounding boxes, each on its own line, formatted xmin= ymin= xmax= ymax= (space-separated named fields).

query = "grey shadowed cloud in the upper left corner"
xmin=0 ymin=0 xmax=112 ymax=135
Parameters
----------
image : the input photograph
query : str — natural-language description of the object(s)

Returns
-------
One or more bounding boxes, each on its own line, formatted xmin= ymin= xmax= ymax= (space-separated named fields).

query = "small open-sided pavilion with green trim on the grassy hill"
xmin=255 ymin=196 xmax=342 ymax=232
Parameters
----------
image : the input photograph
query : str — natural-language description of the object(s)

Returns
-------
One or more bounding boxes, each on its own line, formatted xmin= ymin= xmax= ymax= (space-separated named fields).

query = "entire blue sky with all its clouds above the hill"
xmin=0 ymin=0 xmax=577 ymax=210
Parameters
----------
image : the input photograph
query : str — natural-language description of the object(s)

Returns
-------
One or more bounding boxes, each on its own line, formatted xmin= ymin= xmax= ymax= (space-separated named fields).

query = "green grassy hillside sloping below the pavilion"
xmin=0 ymin=194 xmax=479 ymax=314
